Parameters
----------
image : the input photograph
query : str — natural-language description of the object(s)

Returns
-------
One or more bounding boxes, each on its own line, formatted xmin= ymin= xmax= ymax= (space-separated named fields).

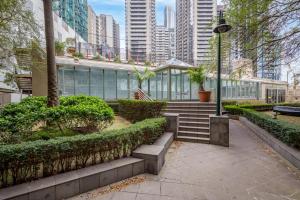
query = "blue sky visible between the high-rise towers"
xmin=88 ymin=0 xmax=176 ymax=48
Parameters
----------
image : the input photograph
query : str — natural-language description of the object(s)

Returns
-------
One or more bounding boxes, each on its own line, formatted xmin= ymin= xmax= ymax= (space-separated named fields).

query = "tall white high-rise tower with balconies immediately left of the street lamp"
xmin=176 ymin=0 xmax=217 ymax=65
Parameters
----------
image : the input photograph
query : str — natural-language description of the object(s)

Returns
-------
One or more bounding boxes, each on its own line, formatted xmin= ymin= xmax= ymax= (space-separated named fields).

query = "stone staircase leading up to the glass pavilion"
xmin=164 ymin=102 xmax=216 ymax=144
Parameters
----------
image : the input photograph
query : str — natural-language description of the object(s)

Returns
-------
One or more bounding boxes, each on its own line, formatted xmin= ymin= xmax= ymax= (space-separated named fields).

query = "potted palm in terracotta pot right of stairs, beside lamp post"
xmin=188 ymin=67 xmax=211 ymax=102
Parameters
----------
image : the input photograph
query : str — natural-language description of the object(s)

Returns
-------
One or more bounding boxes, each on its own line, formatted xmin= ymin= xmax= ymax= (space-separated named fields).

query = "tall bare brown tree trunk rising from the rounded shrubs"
xmin=43 ymin=0 xmax=58 ymax=107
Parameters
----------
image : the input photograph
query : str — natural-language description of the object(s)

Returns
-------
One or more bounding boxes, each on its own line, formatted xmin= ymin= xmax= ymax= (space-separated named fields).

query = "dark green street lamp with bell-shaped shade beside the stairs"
xmin=214 ymin=11 xmax=231 ymax=116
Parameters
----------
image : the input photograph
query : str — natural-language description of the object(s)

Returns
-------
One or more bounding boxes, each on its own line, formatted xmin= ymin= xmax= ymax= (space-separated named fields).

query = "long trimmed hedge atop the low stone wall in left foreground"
xmin=0 ymin=118 xmax=166 ymax=187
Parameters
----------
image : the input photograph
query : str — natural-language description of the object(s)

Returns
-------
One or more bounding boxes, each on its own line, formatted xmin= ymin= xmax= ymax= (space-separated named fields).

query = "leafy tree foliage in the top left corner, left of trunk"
xmin=0 ymin=0 xmax=40 ymax=67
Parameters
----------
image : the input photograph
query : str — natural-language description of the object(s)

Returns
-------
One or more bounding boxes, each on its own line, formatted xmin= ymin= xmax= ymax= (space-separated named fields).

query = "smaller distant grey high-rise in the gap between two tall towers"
xmin=155 ymin=26 xmax=170 ymax=64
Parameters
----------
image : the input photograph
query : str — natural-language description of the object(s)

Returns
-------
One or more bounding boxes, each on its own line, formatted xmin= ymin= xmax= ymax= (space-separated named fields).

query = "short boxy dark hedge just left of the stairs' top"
xmin=118 ymin=100 xmax=167 ymax=122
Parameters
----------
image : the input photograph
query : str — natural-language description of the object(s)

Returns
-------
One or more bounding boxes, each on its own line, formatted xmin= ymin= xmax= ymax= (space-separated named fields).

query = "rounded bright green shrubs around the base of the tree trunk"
xmin=0 ymin=96 xmax=114 ymax=142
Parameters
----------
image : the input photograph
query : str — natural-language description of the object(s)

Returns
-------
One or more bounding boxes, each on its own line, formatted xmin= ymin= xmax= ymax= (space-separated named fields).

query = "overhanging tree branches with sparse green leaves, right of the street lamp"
xmin=224 ymin=0 xmax=300 ymax=74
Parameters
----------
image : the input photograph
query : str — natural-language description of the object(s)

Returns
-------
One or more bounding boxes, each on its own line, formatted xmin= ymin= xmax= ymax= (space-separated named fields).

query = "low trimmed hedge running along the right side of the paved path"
xmin=225 ymin=106 xmax=300 ymax=149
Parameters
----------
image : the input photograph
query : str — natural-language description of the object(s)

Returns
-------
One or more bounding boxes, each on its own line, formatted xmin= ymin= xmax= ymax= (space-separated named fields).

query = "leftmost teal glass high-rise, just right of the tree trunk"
xmin=53 ymin=0 xmax=88 ymax=41
